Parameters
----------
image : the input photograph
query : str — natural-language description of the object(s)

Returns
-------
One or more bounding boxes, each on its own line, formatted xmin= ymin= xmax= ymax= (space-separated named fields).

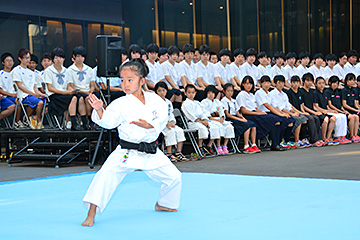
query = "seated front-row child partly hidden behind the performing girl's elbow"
xmin=154 ymin=82 xmax=189 ymax=162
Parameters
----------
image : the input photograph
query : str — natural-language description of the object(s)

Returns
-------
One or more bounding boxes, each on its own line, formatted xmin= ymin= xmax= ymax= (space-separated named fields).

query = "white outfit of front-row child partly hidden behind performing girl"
xmin=161 ymin=98 xmax=186 ymax=146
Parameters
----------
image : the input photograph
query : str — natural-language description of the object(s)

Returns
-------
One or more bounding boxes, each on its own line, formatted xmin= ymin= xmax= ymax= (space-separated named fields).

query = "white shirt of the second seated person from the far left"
xmin=11 ymin=65 xmax=36 ymax=100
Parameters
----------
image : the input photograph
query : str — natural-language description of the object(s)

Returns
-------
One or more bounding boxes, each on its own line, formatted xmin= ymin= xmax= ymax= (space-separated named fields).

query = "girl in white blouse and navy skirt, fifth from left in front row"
xmin=236 ymin=76 xmax=284 ymax=151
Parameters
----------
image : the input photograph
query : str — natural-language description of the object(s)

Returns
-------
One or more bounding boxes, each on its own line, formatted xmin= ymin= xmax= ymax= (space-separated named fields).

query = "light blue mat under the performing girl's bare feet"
xmin=0 ymin=172 xmax=360 ymax=240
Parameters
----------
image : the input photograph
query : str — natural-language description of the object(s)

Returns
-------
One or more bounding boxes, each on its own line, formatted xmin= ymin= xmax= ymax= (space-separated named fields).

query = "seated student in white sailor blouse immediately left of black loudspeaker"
xmin=67 ymin=46 xmax=95 ymax=130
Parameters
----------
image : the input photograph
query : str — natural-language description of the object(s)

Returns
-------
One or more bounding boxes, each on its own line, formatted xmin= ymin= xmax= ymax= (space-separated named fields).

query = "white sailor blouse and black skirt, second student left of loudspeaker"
xmin=44 ymin=65 xmax=75 ymax=116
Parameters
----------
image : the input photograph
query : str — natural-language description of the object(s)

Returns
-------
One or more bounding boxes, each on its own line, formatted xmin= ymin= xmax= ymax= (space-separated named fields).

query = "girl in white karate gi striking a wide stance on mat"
xmin=82 ymin=59 xmax=181 ymax=227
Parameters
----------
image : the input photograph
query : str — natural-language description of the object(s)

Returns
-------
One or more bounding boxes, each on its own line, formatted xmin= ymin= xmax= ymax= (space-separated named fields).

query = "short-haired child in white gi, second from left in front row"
xmin=181 ymin=84 xmax=220 ymax=155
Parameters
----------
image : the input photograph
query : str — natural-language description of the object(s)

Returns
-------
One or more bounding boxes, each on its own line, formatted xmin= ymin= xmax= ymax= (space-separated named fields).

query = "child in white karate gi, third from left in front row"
xmin=201 ymin=85 xmax=235 ymax=154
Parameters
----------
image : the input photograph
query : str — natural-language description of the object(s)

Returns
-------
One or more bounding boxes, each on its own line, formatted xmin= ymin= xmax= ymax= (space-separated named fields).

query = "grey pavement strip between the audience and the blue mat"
xmin=0 ymin=144 xmax=360 ymax=182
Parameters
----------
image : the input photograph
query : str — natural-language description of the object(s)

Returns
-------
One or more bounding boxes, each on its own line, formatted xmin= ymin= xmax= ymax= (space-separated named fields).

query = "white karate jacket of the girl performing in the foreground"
xmin=91 ymin=91 xmax=171 ymax=170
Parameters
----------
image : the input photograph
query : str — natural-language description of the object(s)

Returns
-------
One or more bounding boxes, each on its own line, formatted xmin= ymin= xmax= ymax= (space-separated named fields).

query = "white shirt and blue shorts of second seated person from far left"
xmin=11 ymin=65 xmax=45 ymax=108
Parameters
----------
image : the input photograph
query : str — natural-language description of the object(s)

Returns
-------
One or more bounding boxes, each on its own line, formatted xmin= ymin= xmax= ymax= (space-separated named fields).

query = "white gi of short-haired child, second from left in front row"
xmin=181 ymin=98 xmax=221 ymax=139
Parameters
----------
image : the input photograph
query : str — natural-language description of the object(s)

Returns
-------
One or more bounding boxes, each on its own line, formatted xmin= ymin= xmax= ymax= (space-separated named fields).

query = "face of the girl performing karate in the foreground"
xmin=120 ymin=68 xmax=145 ymax=94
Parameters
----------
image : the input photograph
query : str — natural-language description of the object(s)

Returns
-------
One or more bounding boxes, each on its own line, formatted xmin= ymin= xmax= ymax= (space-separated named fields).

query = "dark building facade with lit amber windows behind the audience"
xmin=0 ymin=0 xmax=360 ymax=66
